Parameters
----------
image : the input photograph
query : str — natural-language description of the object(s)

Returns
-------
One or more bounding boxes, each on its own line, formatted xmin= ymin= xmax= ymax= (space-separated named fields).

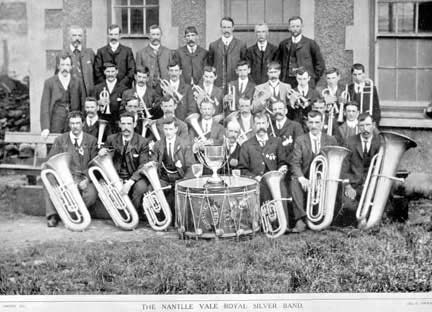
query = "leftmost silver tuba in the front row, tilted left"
xmin=41 ymin=153 xmax=91 ymax=231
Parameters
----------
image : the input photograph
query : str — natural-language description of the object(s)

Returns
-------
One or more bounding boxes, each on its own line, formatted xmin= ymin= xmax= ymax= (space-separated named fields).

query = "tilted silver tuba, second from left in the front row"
xmin=89 ymin=154 xmax=139 ymax=230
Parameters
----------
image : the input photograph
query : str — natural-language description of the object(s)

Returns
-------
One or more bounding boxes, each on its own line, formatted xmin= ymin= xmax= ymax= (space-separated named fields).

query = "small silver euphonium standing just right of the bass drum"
xmin=261 ymin=170 xmax=288 ymax=238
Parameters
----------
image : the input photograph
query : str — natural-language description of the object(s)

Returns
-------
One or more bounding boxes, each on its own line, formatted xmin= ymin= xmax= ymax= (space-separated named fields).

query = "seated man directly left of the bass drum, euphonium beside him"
xmin=152 ymin=116 xmax=195 ymax=220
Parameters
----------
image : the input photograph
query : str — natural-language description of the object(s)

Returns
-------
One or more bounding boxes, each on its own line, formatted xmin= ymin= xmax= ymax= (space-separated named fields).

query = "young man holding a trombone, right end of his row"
xmin=348 ymin=63 xmax=381 ymax=127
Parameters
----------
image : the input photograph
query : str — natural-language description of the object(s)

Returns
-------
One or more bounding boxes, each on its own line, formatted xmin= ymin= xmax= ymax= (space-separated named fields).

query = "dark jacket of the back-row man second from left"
xmin=94 ymin=44 xmax=135 ymax=88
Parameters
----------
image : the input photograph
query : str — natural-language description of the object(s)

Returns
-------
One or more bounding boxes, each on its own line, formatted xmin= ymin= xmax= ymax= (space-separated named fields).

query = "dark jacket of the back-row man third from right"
xmin=208 ymin=37 xmax=246 ymax=89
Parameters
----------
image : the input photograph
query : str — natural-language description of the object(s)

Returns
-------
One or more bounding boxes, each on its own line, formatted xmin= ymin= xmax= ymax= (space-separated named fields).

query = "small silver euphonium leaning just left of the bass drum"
xmin=142 ymin=161 xmax=172 ymax=231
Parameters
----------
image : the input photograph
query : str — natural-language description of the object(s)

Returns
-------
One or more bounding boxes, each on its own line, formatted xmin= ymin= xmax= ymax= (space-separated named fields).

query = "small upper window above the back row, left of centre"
xmin=112 ymin=0 xmax=159 ymax=37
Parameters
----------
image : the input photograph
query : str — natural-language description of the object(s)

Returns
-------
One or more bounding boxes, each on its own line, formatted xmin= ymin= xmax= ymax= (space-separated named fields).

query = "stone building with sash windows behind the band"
xmin=0 ymin=0 xmax=432 ymax=131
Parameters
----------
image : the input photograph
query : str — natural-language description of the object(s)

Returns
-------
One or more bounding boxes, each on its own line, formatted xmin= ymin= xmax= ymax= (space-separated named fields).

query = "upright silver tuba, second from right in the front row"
xmin=306 ymin=146 xmax=351 ymax=231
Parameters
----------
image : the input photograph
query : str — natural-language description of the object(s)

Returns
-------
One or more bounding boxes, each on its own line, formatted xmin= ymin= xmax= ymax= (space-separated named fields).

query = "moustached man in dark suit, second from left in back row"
xmin=94 ymin=25 xmax=135 ymax=88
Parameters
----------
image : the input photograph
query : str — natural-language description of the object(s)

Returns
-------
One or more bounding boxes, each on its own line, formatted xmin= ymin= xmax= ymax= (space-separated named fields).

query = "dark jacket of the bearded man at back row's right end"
xmin=274 ymin=35 xmax=325 ymax=82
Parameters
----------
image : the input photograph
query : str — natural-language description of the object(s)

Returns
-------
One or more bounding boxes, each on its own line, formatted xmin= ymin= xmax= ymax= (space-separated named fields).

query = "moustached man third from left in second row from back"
xmin=122 ymin=66 xmax=162 ymax=119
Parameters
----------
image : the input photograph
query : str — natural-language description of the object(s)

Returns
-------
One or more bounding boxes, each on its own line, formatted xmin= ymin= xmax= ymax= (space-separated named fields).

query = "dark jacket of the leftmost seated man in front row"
xmin=48 ymin=132 xmax=97 ymax=176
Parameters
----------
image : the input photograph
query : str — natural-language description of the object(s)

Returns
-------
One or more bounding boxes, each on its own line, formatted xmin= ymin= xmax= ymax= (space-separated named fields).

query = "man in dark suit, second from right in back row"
xmin=246 ymin=24 xmax=277 ymax=85
